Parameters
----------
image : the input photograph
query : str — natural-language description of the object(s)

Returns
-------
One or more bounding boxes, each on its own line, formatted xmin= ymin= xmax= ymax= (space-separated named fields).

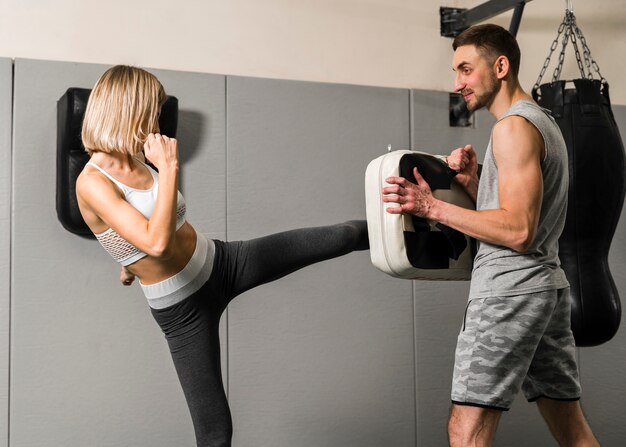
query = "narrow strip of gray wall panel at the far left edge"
xmin=0 ymin=58 xmax=13 ymax=447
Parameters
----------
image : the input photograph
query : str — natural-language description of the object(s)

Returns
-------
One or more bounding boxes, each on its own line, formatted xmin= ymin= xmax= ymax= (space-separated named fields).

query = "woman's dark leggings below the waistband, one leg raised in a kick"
xmin=152 ymin=221 xmax=369 ymax=447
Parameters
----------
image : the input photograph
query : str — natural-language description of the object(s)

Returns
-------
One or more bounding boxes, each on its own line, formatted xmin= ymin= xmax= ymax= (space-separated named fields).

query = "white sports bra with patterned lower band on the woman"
xmin=87 ymin=160 xmax=187 ymax=266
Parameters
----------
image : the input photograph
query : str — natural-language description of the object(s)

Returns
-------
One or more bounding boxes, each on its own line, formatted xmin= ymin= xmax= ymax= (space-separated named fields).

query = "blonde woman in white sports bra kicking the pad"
xmin=76 ymin=66 xmax=368 ymax=446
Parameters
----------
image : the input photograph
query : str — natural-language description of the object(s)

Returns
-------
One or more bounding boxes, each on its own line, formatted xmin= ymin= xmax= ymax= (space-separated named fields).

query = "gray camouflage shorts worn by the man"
xmin=452 ymin=289 xmax=580 ymax=410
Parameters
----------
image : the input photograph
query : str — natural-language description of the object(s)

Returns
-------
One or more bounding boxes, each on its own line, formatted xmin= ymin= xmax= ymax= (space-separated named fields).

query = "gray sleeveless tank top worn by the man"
xmin=470 ymin=101 xmax=569 ymax=299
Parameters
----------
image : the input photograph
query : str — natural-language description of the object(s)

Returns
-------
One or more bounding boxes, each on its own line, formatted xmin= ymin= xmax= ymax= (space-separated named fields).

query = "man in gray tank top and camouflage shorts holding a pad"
xmin=383 ymin=25 xmax=599 ymax=446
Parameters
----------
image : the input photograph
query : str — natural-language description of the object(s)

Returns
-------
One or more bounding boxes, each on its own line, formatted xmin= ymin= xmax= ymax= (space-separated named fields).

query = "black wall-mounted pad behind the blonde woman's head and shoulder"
xmin=56 ymin=88 xmax=178 ymax=238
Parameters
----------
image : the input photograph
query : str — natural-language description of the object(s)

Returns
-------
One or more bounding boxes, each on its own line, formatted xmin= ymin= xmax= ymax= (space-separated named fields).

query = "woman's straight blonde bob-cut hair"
xmin=81 ymin=65 xmax=166 ymax=156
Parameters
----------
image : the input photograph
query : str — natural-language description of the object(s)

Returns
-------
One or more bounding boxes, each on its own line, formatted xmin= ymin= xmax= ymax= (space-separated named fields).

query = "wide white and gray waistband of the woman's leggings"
xmin=139 ymin=233 xmax=215 ymax=309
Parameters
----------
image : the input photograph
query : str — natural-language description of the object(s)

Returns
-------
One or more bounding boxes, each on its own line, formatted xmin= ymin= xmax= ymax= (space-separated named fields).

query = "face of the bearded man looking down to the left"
xmin=452 ymin=45 xmax=500 ymax=112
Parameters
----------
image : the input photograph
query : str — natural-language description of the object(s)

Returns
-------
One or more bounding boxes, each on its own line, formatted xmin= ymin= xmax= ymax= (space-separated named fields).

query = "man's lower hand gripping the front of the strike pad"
xmin=383 ymin=168 xmax=437 ymax=218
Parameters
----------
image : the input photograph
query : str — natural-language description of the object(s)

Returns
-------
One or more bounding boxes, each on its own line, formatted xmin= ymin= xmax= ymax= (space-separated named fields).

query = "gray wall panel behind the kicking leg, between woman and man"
xmin=227 ymin=77 xmax=415 ymax=447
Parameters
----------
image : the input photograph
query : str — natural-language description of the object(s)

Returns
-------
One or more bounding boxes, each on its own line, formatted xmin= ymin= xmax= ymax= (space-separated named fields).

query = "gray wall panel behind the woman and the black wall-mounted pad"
xmin=10 ymin=60 xmax=226 ymax=447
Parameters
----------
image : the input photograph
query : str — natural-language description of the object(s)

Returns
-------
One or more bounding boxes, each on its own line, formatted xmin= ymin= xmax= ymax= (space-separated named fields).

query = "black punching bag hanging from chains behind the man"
xmin=533 ymin=10 xmax=626 ymax=346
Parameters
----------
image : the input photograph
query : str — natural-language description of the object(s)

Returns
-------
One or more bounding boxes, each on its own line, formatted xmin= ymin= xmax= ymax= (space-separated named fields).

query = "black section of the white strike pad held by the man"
xmin=400 ymin=154 xmax=467 ymax=269
